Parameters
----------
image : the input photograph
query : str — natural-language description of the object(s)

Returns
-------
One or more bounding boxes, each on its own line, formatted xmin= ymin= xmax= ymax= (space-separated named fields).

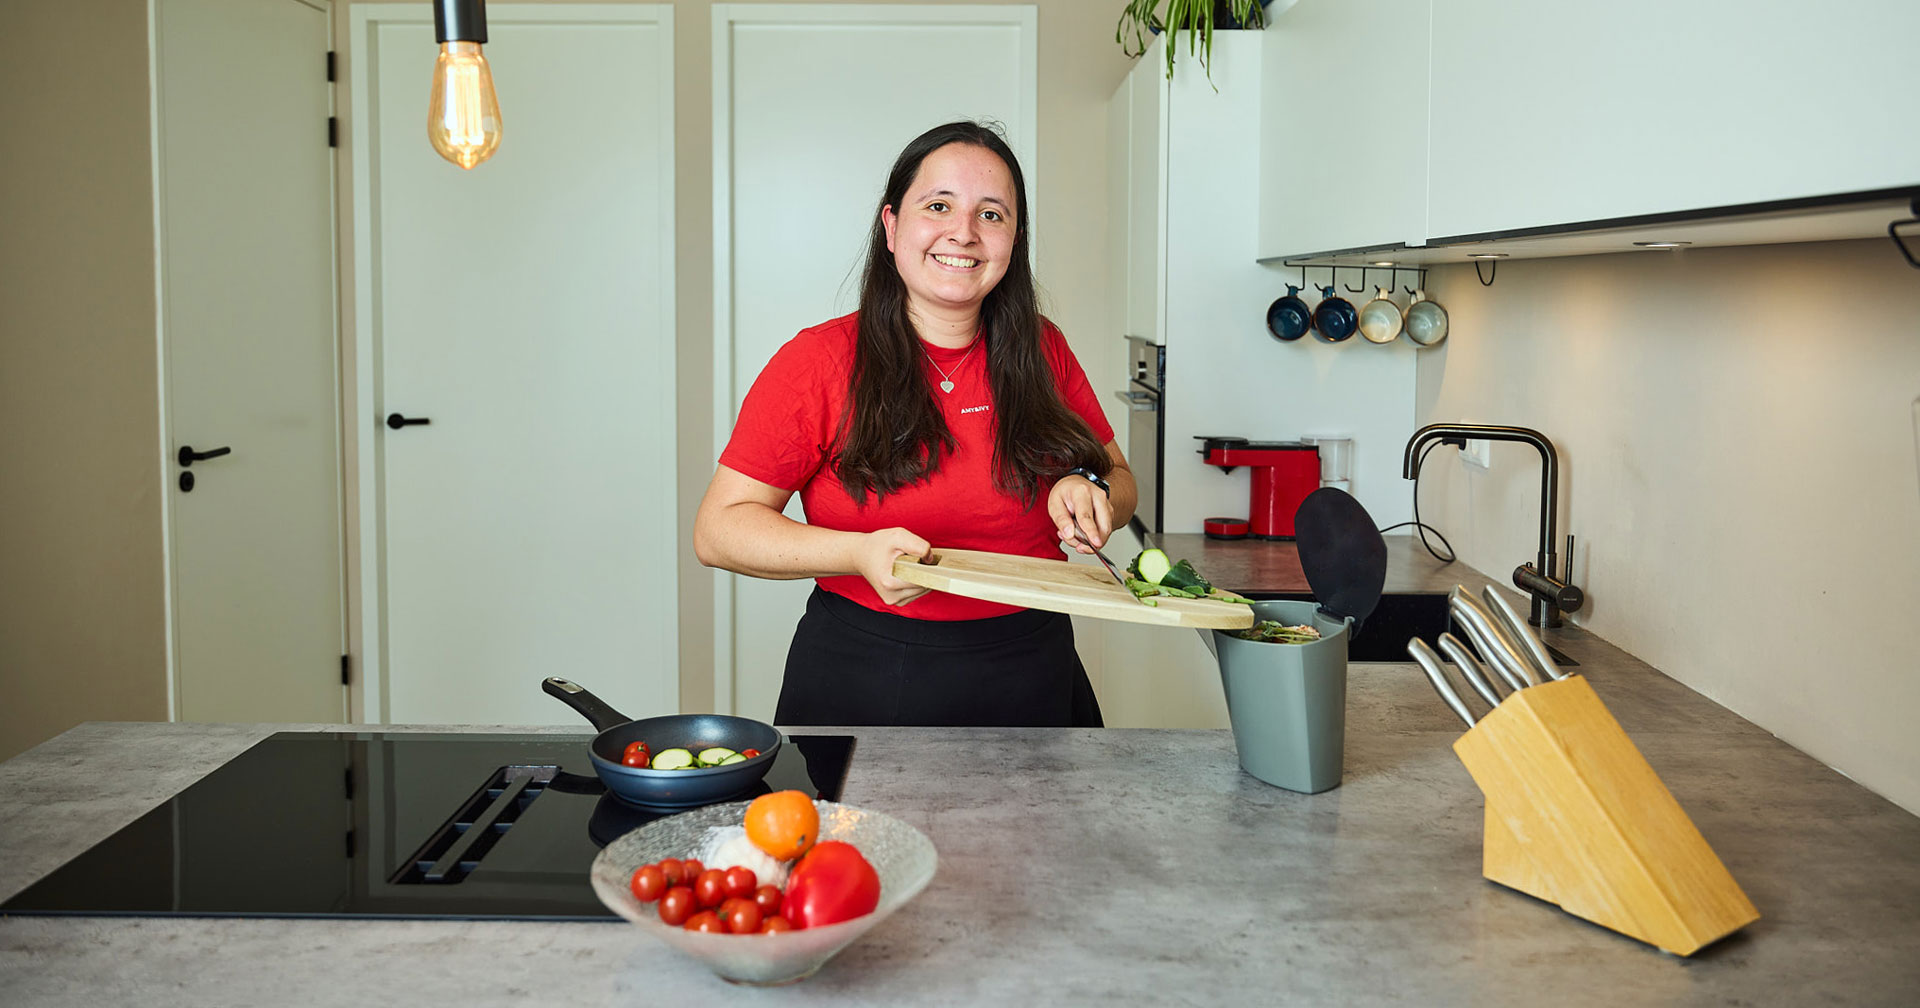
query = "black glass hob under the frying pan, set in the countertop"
xmin=0 ymin=732 xmax=854 ymax=920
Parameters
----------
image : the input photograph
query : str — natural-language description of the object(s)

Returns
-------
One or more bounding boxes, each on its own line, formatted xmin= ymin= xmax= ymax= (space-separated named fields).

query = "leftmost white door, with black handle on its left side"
xmin=154 ymin=0 xmax=346 ymax=722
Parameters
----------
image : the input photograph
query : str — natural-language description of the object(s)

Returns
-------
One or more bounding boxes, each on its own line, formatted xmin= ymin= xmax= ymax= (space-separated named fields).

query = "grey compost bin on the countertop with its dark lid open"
xmin=1202 ymin=488 xmax=1386 ymax=795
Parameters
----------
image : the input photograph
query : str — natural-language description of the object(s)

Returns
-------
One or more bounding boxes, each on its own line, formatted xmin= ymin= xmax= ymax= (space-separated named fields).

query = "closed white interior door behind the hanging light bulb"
xmin=353 ymin=4 xmax=680 ymax=728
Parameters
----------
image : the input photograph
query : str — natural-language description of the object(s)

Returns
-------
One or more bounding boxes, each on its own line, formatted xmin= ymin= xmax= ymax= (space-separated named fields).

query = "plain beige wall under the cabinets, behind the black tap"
xmin=1417 ymin=240 xmax=1920 ymax=812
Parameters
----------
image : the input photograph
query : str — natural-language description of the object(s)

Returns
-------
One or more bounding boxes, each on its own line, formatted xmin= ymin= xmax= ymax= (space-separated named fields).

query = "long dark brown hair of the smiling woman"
xmin=835 ymin=123 xmax=1114 ymax=507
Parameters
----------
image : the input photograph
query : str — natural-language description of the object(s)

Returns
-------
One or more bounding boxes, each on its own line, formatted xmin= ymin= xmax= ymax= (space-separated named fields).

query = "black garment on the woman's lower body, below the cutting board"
xmin=774 ymin=586 xmax=1104 ymax=728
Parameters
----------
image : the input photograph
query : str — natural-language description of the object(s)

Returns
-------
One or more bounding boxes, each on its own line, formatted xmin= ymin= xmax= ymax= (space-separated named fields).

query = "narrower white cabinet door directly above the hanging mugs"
xmin=1260 ymin=0 xmax=1430 ymax=255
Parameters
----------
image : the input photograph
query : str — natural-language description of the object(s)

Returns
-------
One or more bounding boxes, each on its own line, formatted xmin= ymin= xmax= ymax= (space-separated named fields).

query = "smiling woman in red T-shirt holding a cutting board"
xmin=693 ymin=123 xmax=1135 ymax=726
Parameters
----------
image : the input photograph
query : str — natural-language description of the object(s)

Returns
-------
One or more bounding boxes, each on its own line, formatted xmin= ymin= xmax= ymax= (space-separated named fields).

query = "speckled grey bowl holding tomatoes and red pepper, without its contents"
xmin=591 ymin=799 xmax=939 ymax=987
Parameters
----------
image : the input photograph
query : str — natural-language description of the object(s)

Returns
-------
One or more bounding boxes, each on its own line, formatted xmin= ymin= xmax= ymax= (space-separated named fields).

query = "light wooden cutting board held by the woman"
xmin=893 ymin=549 xmax=1254 ymax=630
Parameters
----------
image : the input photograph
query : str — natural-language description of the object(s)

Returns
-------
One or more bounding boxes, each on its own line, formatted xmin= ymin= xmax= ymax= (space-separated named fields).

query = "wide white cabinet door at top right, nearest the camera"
xmin=1436 ymin=0 xmax=1920 ymax=238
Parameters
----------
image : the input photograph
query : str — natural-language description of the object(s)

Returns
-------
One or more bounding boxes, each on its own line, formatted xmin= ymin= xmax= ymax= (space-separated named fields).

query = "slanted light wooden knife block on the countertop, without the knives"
xmin=1453 ymin=676 xmax=1761 ymax=956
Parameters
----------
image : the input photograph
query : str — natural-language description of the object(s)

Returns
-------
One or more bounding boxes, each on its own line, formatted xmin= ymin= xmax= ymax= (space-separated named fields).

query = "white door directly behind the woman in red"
xmin=712 ymin=4 xmax=1039 ymax=718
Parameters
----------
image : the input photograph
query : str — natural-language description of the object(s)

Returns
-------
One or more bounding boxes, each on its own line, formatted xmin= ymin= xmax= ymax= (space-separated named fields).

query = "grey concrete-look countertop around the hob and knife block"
xmin=0 ymin=630 xmax=1920 ymax=1006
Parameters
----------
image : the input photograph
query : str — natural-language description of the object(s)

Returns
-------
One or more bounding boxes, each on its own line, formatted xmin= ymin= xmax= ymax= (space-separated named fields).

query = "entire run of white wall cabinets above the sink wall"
xmin=1260 ymin=0 xmax=1920 ymax=261
